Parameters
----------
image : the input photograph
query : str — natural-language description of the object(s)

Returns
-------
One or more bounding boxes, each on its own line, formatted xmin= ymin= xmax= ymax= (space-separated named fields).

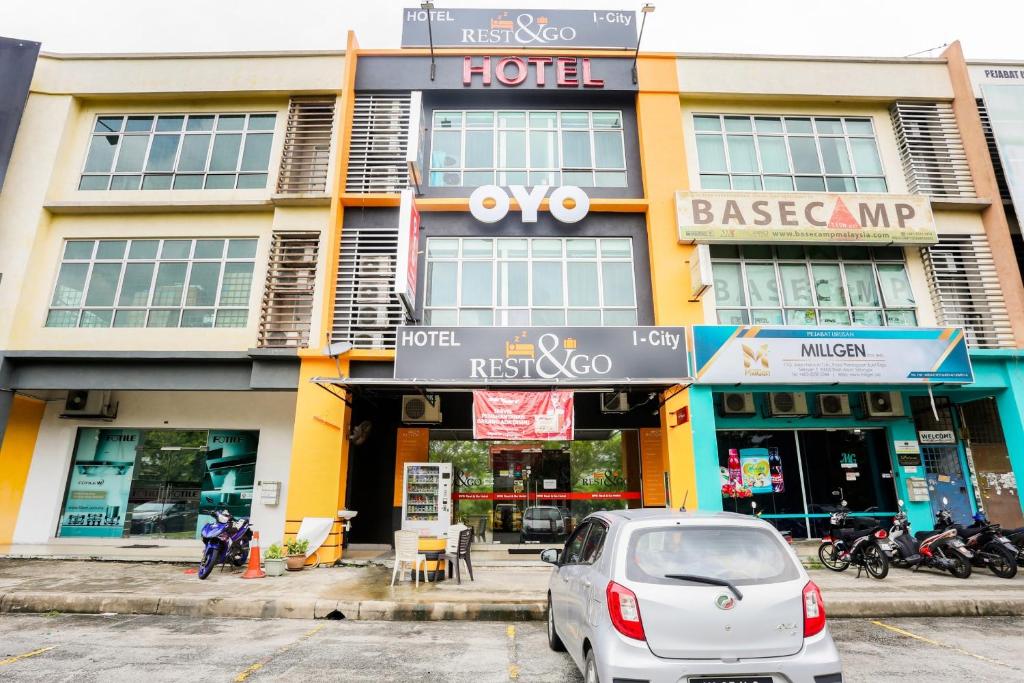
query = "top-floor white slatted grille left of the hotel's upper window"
xmin=345 ymin=92 xmax=412 ymax=193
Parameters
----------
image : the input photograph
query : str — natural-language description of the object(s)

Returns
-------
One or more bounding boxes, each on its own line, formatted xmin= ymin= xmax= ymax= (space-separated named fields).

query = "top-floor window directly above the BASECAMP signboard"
xmin=692 ymin=112 xmax=889 ymax=193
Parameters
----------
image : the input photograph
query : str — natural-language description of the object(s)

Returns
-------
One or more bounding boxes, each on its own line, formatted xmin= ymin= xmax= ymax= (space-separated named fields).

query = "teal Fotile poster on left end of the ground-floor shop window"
xmin=58 ymin=428 xmax=141 ymax=538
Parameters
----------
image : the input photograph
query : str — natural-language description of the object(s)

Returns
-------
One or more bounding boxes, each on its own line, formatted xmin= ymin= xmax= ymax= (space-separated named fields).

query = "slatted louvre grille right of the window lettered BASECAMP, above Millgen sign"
xmin=921 ymin=234 xmax=1014 ymax=348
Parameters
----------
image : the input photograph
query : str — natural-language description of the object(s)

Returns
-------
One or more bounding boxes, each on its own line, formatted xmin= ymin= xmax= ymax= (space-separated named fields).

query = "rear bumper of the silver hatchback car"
xmin=595 ymin=629 xmax=842 ymax=683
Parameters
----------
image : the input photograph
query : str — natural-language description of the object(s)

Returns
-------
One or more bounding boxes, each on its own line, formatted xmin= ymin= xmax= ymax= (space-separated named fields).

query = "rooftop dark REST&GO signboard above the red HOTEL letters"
xmin=401 ymin=7 xmax=637 ymax=50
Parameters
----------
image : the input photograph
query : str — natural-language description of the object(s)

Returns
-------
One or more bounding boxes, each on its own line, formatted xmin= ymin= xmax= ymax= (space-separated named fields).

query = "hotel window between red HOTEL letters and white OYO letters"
xmin=428 ymin=109 xmax=629 ymax=187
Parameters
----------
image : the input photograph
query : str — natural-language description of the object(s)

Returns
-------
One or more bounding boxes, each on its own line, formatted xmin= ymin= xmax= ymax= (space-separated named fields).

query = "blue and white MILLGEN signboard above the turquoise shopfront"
xmin=693 ymin=325 xmax=974 ymax=386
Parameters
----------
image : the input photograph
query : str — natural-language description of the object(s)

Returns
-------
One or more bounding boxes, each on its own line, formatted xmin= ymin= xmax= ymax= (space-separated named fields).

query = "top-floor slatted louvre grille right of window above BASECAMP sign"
xmin=889 ymin=101 xmax=975 ymax=199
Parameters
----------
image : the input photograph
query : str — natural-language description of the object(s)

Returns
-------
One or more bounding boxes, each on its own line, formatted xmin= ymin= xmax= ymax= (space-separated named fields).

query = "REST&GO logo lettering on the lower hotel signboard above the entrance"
xmin=469 ymin=330 xmax=612 ymax=380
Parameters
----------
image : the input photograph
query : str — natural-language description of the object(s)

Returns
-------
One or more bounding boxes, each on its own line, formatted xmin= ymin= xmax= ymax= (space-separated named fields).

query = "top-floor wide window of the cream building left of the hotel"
xmin=78 ymin=111 xmax=278 ymax=191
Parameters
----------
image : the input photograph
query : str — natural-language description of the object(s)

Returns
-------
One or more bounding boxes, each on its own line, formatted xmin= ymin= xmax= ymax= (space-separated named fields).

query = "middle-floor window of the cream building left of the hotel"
xmin=44 ymin=237 xmax=259 ymax=329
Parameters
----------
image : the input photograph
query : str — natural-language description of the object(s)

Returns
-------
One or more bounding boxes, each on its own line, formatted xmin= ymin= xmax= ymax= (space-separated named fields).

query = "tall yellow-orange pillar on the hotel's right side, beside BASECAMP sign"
xmin=637 ymin=54 xmax=703 ymax=509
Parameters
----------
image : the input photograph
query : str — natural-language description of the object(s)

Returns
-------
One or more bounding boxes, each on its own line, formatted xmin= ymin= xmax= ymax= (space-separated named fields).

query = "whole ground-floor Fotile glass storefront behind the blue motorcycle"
xmin=57 ymin=428 xmax=259 ymax=539
